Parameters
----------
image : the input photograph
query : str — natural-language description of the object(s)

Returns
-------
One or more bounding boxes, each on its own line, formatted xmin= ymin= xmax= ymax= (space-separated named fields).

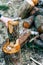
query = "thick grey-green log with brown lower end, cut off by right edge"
xmin=35 ymin=15 xmax=43 ymax=33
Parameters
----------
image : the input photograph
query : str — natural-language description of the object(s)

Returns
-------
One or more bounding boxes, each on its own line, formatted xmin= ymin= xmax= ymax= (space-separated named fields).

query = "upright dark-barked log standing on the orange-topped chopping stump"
xmin=8 ymin=21 xmax=19 ymax=41
